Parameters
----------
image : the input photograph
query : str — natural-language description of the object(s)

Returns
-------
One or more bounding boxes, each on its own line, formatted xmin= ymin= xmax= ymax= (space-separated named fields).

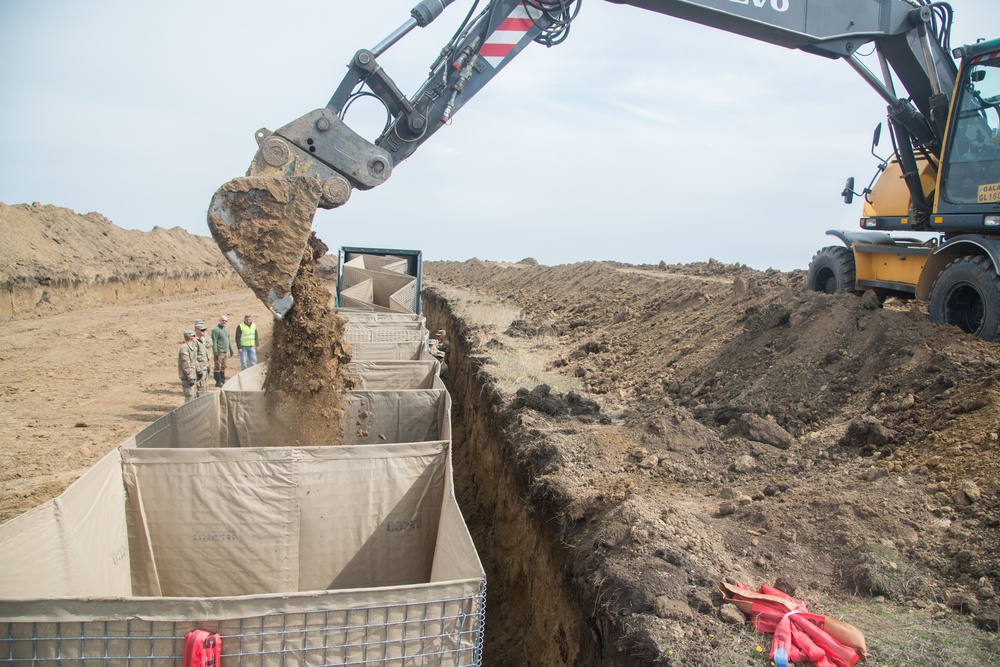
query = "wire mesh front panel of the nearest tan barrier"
xmin=0 ymin=578 xmax=486 ymax=667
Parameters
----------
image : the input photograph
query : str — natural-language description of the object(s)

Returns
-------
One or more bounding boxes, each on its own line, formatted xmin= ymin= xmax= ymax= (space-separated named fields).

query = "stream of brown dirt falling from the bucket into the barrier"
xmin=264 ymin=234 xmax=353 ymax=446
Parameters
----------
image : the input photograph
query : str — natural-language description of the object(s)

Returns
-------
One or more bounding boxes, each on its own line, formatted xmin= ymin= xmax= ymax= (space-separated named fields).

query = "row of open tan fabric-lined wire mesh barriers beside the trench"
xmin=0 ymin=315 xmax=486 ymax=667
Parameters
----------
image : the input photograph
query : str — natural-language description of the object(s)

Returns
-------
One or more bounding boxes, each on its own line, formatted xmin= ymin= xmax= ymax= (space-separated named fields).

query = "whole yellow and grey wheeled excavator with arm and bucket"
xmin=208 ymin=0 xmax=1000 ymax=340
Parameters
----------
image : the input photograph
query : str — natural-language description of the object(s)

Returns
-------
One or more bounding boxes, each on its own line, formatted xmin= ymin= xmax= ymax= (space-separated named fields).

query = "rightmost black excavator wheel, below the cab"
xmin=929 ymin=255 xmax=1000 ymax=340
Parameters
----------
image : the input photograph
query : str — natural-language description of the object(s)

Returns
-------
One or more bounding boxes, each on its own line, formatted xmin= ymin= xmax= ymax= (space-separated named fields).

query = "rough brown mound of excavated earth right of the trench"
xmin=424 ymin=260 xmax=1000 ymax=665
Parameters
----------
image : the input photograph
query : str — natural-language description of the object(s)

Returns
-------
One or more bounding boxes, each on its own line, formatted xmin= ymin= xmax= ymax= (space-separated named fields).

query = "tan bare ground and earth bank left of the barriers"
xmin=0 ymin=204 xmax=271 ymax=521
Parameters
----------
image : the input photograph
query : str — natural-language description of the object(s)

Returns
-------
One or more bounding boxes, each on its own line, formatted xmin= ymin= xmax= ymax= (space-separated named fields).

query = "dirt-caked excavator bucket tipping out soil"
xmin=208 ymin=176 xmax=323 ymax=319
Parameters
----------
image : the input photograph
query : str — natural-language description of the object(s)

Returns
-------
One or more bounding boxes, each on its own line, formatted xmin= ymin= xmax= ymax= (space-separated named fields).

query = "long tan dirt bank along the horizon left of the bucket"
xmin=0 ymin=203 xmax=239 ymax=317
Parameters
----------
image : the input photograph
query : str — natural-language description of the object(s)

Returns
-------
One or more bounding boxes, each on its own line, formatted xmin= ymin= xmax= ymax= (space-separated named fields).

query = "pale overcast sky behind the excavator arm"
xmin=0 ymin=0 xmax=1000 ymax=270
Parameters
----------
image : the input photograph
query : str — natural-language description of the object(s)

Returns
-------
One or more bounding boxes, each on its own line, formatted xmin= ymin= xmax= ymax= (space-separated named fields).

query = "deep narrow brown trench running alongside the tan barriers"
xmin=423 ymin=290 xmax=638 ymax=667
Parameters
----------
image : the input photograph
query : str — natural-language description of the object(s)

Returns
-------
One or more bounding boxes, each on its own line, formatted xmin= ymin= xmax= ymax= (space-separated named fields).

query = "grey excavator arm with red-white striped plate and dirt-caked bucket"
xmin=208 ymin=0 xmax=957 ymax=318
